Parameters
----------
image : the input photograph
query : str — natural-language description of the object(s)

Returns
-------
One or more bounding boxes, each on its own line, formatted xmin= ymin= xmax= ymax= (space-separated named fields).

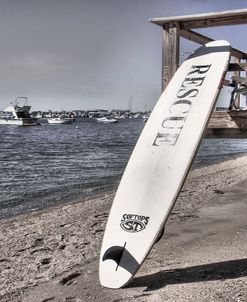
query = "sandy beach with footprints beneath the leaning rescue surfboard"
xmin=0 ymin=156 xmax=247 ymax=302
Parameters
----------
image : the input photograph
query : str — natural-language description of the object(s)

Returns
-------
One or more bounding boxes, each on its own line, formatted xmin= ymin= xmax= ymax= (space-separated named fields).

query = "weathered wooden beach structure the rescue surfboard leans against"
xmin=149 ymin=9 xmax=247 ymax=137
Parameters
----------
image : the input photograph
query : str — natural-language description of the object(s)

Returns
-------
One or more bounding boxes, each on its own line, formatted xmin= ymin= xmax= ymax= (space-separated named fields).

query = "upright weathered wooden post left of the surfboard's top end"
xmin=162 ymin=23 xmax=179 ymax=91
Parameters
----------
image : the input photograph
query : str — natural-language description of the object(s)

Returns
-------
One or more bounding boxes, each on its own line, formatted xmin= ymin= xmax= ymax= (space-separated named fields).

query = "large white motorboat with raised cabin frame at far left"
xmin=0 ymin=97 xmax=40 ymax=126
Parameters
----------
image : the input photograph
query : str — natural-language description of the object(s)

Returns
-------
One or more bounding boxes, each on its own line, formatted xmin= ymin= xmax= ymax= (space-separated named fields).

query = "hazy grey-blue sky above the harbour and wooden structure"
xmin=0 ymin=0 xmax=247 ymax=110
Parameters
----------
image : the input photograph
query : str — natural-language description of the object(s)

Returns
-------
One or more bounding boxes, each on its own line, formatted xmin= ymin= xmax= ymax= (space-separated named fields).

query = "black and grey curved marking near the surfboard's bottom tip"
xmin=102 ymin=242 xmax=140 ymax=274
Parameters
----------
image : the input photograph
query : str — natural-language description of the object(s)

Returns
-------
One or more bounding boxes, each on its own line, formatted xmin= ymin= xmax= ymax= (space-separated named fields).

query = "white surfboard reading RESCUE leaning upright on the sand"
xmin=99 ymin=41 xmax=230 ymax=288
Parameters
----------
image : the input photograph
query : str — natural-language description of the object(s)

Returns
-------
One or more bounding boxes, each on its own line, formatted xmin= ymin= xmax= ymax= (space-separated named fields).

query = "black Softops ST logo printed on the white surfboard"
xmin=120 ymin=214 xmax=149 ymax=233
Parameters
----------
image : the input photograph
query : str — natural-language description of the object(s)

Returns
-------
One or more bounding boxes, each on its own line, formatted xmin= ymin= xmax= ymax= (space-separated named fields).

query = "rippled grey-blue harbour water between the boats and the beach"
xmin=0 ymin=119 xmax=247 ymax=218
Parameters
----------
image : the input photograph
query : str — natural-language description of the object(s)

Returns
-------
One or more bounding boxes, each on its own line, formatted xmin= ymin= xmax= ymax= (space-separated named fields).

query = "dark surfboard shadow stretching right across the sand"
xmin=128 ymin=259 xmax=247 ymax=291
